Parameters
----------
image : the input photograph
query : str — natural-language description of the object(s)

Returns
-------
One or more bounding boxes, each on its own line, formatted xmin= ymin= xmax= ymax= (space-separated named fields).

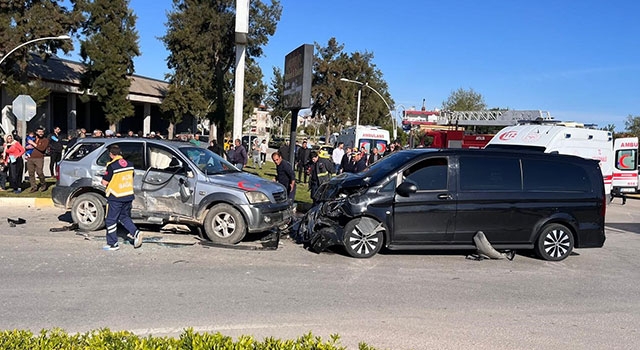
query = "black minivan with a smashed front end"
xmin=297 ymin=149 xmax=606 ymax=261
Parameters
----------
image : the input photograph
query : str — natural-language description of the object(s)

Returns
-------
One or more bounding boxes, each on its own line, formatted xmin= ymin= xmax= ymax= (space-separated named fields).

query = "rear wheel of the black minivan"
xmin=536 ymin=224 xmax=574 ymax=261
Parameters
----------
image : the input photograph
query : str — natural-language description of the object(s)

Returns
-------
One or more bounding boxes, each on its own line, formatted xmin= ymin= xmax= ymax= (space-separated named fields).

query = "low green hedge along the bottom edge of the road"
xmin=0 ymin=328 xmax=375 ymax=350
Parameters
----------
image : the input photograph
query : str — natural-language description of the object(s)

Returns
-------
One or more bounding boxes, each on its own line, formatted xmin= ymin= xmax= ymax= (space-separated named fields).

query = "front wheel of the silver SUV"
xmin=204 ymin=204 xmax=247 ymax=244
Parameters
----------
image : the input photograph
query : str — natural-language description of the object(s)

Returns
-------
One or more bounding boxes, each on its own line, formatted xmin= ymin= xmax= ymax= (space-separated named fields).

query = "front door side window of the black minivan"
xmin=403 ymin=158 xmax=449 ymax=191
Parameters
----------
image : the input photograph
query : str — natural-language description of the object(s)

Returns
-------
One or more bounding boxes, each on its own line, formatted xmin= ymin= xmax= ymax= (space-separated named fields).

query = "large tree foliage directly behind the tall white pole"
xmin=161 ymin=0 xmax=282 ymax=139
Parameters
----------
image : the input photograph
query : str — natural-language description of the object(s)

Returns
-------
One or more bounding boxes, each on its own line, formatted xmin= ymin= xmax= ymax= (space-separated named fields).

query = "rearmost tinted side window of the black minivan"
xmin=522 ymin=159 xmax=591 ymax=192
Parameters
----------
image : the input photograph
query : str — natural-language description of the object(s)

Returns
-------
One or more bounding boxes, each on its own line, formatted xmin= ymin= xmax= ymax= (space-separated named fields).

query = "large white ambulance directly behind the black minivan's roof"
xmin=485 ymin=122 xmax=613 ymax=195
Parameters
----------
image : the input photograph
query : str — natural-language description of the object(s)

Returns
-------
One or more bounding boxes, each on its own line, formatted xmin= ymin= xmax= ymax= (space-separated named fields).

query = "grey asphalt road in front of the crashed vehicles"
xmin=0 ymin=199 xmax=640 ymax=349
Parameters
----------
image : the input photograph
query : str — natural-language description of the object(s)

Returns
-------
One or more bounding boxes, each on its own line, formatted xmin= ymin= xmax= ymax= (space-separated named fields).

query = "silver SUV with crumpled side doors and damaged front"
xmin=51 ymin=138 xmax=292 ymax=244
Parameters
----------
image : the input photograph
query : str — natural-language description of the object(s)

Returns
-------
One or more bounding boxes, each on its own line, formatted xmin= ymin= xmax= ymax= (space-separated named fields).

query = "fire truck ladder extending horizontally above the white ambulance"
xmin=436 ymin=110 xmax=554 ymax=126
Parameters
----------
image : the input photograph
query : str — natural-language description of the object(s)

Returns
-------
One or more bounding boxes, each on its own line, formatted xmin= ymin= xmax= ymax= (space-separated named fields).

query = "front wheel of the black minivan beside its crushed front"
xmin=343 ymin=218 xmax=384 ymax=258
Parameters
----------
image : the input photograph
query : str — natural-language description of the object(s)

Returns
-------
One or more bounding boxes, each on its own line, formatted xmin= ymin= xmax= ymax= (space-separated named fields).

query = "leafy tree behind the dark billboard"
xmin=311 ymin=38 xmax=394 ymax=136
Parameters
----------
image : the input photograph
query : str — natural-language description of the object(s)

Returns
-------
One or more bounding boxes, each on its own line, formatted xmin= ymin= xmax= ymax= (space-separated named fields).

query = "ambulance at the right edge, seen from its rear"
xmin=612 ymin=137 xmax=640 ymax=193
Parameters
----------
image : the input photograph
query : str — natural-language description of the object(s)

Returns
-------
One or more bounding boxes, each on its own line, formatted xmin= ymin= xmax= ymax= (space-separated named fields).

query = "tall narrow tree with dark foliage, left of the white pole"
xmin=80 ymin=0 xmax=140 ymax=124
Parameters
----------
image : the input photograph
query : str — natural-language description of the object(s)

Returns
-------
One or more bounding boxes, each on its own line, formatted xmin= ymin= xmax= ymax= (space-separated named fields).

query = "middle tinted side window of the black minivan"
xmin=460 ymin=156 xmax=522 ymax=191
